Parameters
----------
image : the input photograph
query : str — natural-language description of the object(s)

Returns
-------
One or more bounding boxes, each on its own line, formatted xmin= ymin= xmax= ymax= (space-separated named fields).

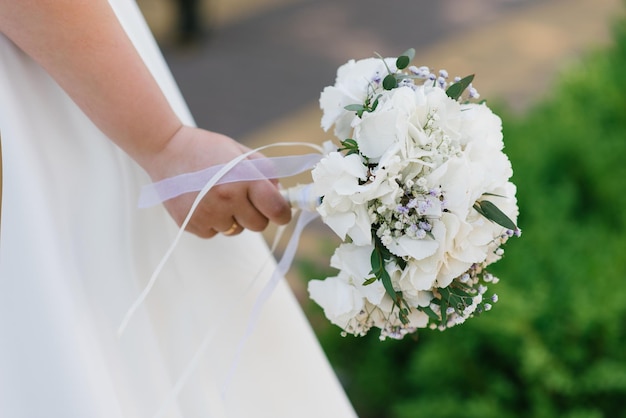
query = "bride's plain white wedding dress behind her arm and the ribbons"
xmin=0 ymin=0 xmax=355 ymax=418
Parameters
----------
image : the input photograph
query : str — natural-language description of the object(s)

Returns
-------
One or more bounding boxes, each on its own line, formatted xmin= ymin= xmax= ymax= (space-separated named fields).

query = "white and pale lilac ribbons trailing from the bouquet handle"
xmin=118 ymin=142 xmax=323 ymax=418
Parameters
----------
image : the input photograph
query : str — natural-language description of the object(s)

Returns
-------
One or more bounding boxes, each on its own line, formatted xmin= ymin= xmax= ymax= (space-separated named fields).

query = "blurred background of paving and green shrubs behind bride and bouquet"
xmin=138 ymin=0 xmax=626 ymax=418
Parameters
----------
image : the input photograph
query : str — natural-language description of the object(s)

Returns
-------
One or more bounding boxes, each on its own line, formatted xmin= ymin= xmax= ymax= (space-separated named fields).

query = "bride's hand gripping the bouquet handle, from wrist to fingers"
xmin=143 ymin=126 xmax=291 ymax=238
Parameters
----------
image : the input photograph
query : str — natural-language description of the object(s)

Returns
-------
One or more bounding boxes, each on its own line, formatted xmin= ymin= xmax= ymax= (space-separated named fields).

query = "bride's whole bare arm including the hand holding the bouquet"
xmin=0 ymin=0 xmax=290 ymax=237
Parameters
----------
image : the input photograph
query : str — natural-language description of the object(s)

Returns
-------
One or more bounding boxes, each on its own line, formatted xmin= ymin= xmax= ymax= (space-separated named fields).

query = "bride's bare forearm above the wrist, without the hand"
xmin=0 ymin=0 xmax=181 ymax=163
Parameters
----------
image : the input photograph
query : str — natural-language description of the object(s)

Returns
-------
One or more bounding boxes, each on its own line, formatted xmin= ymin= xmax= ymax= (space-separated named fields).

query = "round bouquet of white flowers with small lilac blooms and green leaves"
xmin=309 ymin=50 xmax=520 ymax=339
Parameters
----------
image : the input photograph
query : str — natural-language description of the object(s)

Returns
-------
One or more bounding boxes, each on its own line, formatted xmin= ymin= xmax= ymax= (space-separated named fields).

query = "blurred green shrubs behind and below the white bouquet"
xmin=306 ymin=13 xmax=626 ymax=418
